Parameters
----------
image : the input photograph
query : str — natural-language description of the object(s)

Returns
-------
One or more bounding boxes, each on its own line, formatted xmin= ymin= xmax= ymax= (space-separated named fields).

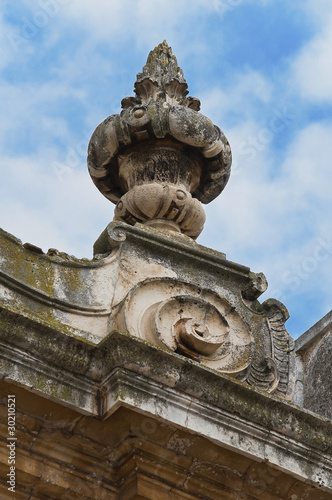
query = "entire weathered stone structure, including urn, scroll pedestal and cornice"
xmin=0 ymin=42 xmax=332 ymax=500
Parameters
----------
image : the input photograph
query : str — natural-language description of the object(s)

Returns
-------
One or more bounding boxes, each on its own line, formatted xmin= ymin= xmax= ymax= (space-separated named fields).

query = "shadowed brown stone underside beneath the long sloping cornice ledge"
xmin=0 ymin=381 xmax=330 ymax=500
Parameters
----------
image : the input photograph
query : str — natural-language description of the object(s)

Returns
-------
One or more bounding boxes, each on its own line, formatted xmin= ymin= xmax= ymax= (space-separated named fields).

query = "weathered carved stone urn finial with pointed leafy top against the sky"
xmin=88 ymin=41 xmax=231 ymax=239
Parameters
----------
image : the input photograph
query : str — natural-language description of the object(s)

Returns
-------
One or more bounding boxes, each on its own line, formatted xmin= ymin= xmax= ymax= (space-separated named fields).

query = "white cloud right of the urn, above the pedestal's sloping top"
xmin=201 ymin=120 xmax=332 ymax=320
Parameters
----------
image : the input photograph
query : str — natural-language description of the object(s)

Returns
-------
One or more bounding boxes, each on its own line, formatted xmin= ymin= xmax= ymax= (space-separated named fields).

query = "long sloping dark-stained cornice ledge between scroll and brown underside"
xmin=1 ymin=308 xmax=332 ymax=492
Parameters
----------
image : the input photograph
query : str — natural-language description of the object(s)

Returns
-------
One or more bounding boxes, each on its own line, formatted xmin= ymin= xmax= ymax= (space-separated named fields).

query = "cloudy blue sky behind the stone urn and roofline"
xmin=0 ymin=0 xmax=332 ymax=337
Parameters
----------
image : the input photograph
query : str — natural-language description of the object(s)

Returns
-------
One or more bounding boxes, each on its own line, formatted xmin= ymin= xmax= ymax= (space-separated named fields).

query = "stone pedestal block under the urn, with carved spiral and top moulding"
xmin=90 ymin=222 xmax=294 ymax=399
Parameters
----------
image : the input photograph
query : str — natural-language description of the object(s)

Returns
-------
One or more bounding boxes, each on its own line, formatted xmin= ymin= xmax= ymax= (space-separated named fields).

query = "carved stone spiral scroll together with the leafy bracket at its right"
xmin=115 ymin=273 xmax=293 ymax=397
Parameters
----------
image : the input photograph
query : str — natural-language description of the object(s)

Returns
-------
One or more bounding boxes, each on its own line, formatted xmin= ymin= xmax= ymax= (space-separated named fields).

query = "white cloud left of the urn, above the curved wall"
xmin=0 ymin=150 xmax=113 ymax=257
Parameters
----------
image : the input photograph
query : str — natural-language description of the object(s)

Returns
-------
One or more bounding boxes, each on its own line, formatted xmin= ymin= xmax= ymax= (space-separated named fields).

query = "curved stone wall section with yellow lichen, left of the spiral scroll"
xmin=0 ymin=231 xmax=117 ymax=344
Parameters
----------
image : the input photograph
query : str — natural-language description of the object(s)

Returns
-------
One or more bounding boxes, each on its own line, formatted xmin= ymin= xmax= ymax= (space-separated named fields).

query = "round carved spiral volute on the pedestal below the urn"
xmin=118 ymin=279 xmax=252 ymax=376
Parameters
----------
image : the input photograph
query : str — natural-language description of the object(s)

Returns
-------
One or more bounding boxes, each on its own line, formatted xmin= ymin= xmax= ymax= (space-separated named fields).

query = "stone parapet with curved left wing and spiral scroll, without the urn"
xmin=0 ymin=223 xmax=293 ymax=398
